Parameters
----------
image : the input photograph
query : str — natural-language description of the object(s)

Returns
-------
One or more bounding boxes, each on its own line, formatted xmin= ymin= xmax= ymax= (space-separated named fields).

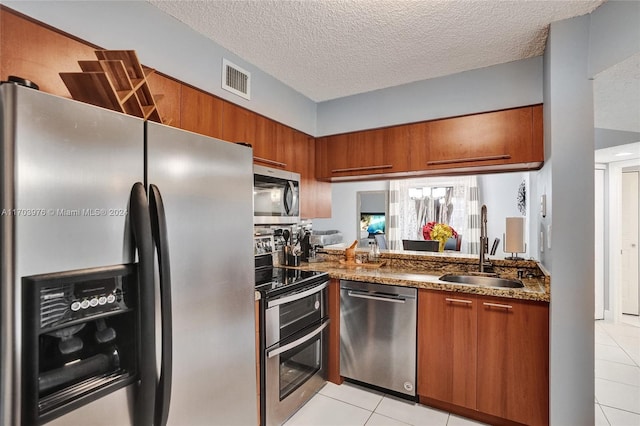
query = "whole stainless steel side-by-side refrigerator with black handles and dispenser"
xmin=0 ymin=84 xmax=257 ymax=426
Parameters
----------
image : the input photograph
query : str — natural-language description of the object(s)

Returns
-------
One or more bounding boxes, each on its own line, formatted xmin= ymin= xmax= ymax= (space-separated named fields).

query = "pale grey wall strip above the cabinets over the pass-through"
xmin=317 ymin=56 xmax=543 ymax=136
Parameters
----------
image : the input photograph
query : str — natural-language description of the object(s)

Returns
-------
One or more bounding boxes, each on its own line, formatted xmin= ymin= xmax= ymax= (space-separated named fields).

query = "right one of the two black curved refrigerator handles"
xmin=149 ymin=184 xmax=173 ymax=426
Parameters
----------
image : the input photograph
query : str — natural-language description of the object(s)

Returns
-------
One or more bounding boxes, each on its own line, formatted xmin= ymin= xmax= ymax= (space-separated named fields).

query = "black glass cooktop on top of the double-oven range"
xmin=256 ymin=267 xmax=329 ymax=297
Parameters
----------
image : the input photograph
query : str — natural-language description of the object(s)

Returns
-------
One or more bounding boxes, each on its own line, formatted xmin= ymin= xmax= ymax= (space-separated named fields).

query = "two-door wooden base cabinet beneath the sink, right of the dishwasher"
xmin=417 ymin=290 xmax=549 ymax=425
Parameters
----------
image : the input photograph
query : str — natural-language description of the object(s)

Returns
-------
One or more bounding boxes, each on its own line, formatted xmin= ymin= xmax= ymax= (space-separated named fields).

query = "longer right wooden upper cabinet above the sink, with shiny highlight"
xmin=411 ymin=106 xmax=544 ymax=171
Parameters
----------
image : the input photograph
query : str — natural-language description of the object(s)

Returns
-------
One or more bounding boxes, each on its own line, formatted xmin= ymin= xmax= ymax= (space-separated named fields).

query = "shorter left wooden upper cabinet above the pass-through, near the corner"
xmin=316 ymin=126 xmax=409 ymax=179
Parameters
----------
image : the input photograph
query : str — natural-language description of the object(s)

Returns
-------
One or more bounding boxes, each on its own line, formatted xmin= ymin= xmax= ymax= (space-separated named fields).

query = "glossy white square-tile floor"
xmin=285 ymin=321 xmax=640 ymax=426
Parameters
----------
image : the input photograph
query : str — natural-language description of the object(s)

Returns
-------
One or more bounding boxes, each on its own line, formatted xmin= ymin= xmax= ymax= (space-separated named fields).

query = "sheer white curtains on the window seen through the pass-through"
xmin=387 ymin=176 xmax=480 ymax=254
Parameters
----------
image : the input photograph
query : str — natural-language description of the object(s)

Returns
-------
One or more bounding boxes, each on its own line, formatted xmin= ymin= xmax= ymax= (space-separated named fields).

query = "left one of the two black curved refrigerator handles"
xmin=129 ymin=182 xmax=156 ymax=426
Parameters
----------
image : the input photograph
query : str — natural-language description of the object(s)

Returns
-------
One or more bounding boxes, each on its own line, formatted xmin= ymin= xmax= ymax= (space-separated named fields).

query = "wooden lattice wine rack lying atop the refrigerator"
xmin=60 ymin=50 xmax=163 ymax=123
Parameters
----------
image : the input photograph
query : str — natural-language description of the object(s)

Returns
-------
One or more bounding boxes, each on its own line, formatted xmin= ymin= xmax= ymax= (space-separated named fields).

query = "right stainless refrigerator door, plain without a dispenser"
xmin=146 ymin=122 xmax=258 ymax=426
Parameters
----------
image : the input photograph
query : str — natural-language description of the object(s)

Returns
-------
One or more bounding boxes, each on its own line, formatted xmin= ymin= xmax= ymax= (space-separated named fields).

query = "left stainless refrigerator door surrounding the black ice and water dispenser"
xmin=0 ymin=84 xmax=144 ymax=425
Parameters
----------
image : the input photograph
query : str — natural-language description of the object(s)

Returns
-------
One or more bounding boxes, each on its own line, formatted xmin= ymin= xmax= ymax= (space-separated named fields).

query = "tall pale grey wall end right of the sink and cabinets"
xmin=541 ymin=15 xmax=595 ymax=425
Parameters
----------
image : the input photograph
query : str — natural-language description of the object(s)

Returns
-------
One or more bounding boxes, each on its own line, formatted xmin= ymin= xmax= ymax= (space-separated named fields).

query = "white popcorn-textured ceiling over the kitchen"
xmin=147 ymin=0 xmax=605 ymax=102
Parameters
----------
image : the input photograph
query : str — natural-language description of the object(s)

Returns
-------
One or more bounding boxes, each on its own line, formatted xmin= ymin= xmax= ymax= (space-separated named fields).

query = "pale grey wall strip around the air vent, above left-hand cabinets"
xmin=1 ymin=0 xmax=316 ymax=135
